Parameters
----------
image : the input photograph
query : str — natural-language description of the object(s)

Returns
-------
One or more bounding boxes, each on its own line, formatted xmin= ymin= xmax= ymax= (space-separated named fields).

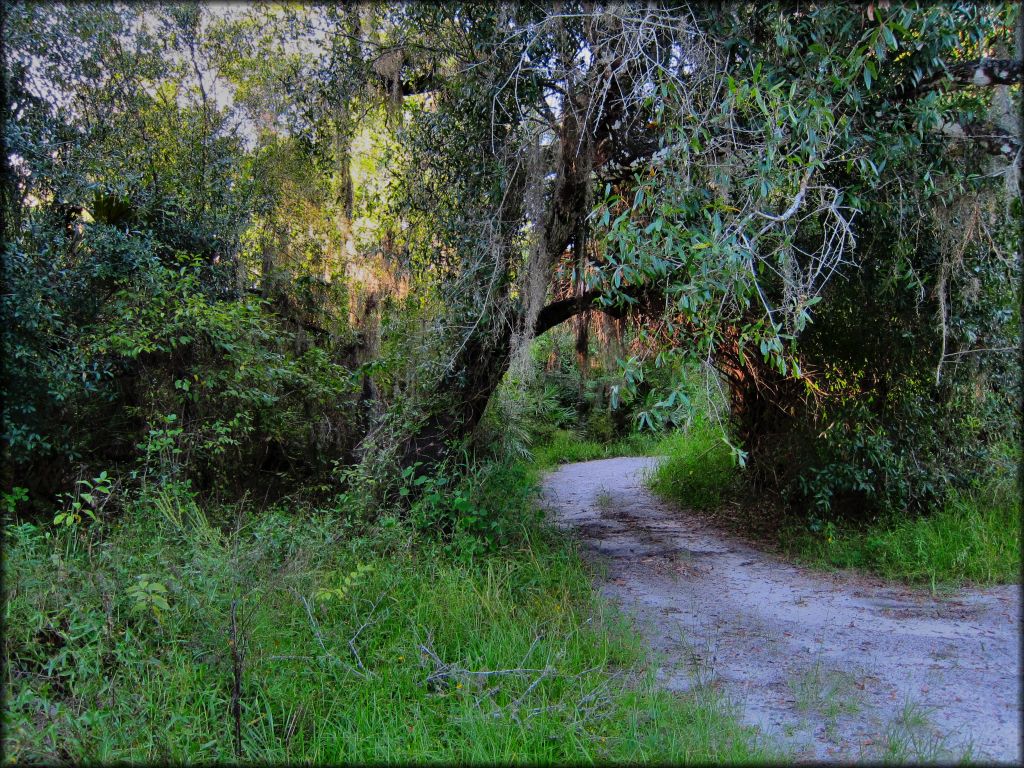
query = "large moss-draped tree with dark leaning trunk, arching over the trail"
xmin=301 ymin=4 xmax=1020 ymax=518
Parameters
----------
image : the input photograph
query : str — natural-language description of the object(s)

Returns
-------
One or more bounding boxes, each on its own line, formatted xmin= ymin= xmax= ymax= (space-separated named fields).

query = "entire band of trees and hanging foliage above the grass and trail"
xmin=2 ymin=2 xmax=1022 ymax=524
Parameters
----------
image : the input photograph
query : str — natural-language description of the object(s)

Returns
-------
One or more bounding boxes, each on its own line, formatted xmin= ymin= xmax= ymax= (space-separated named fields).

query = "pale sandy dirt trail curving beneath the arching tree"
xmin=545 ymin=459 xmax=1021 ymax=763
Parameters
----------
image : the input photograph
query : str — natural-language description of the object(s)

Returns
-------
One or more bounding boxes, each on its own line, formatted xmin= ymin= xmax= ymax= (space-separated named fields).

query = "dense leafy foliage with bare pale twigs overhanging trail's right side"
xmin=600 ymin=5 xmax=1021 ymax=514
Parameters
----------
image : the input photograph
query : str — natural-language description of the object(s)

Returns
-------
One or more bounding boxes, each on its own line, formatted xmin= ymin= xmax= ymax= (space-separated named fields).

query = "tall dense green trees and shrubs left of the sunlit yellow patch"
xmin=3 ymin=5 xmax=368 ymax=505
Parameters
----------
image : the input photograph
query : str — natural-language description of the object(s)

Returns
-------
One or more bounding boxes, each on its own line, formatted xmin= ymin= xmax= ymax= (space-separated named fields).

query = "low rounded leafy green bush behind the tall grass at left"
xmin=2 ymin=237 xmax=356 ymax=497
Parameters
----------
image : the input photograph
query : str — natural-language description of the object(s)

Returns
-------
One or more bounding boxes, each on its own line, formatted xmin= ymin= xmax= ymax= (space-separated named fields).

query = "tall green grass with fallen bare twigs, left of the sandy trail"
xmin=3 ymin=468 xmax=774 ymax=763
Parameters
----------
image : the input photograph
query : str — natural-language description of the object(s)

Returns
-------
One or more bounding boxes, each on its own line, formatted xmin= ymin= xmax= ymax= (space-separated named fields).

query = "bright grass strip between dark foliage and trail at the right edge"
xmin=780 ymin=481 xmax=1021 ymax=588
